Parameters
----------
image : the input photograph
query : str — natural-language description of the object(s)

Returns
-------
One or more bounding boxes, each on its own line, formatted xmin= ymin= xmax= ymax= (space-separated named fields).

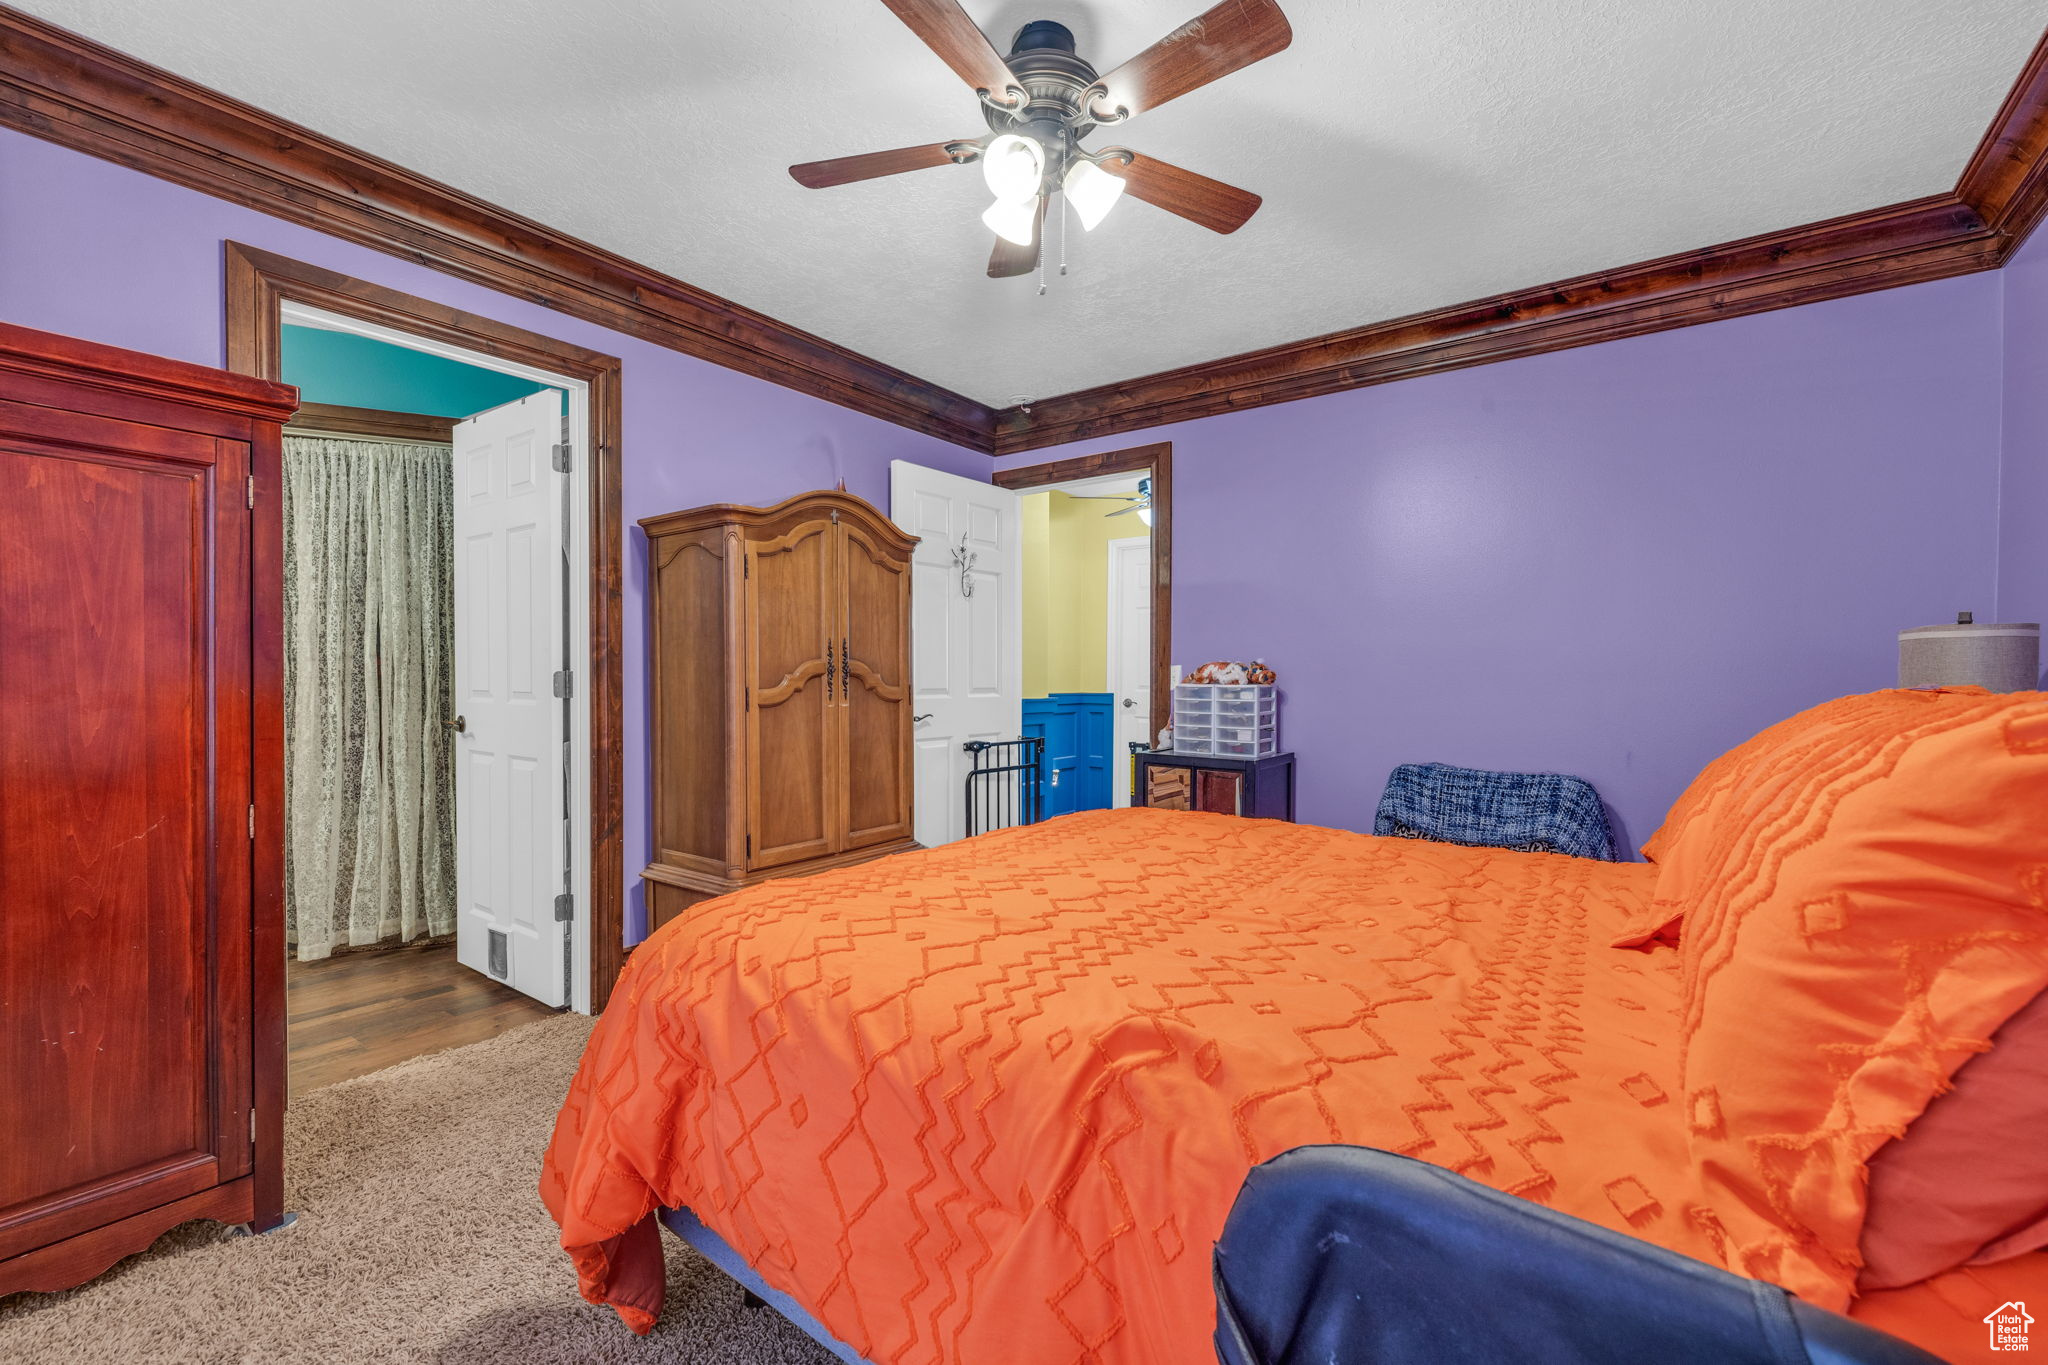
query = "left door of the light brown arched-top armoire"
xmin=743 ymin=516 xmax=844 ymax=868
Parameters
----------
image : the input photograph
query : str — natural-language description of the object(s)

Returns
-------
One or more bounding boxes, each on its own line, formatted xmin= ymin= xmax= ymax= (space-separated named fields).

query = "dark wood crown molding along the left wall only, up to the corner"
xmin=0 ymin=6 xmax=991 ymax=450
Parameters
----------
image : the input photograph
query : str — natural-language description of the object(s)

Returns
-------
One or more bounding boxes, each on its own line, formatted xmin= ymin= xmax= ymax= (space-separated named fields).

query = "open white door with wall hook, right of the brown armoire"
xmin=897 ymin=460 xmax=1024 ymax=847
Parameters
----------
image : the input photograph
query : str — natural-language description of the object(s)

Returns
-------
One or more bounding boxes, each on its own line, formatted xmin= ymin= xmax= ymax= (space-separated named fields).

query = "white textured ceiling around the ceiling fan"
xmin=28 ymin=0 xmax=2048 ymax=405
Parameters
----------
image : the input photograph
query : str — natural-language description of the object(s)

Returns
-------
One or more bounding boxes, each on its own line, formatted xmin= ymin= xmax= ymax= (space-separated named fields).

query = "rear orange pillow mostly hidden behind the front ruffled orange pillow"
xmin=1614 ymin=688 xmax=1989 ymax=948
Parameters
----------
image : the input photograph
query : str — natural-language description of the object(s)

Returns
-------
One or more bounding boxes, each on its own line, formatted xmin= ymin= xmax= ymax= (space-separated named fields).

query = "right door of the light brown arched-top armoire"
xmin=840 ymin=524 xmax=911 ymax=849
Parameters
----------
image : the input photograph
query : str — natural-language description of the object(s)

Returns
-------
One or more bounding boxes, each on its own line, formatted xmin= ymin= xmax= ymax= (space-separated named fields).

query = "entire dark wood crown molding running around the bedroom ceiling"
xmin=0 ymin=4 xmax=2048 ymax=454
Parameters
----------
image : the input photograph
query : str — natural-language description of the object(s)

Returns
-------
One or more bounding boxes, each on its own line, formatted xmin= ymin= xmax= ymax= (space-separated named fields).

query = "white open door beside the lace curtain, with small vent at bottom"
xmin=455 ymin=389 xmax=569 ymax=1005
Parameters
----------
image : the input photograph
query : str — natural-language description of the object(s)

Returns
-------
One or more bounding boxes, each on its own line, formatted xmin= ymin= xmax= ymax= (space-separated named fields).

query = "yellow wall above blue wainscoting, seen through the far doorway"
xmin=1022 ymin=491 xmax=1151 ymax=696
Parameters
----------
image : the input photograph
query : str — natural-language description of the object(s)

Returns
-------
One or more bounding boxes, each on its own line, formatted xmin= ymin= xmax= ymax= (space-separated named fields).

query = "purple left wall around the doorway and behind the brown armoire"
xmin=0 ymin=129 xmax=991 ymax=941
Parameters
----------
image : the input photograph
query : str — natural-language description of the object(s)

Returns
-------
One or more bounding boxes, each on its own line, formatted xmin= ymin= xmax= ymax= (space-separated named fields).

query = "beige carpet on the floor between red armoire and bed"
xmin=0 ymin=1015 xmax=838 ymax=1365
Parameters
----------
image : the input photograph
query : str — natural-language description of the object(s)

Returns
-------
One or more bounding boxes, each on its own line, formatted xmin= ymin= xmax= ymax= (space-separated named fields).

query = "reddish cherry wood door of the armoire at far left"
xmin=0 ymin=435 xmax=252 ymax=1257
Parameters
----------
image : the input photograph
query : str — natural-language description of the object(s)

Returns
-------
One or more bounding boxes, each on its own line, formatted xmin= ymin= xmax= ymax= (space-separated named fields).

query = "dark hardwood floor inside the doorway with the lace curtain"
xmin=287 ymin=943 xmax=557 ymax=1095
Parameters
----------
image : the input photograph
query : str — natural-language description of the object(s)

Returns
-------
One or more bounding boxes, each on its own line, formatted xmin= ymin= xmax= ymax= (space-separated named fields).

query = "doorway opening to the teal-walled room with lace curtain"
xmin=283 ymin=317 xmax=573 ymax=1093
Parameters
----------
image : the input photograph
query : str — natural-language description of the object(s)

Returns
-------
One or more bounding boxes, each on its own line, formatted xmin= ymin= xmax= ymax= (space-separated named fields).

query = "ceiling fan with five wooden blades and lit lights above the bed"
xmin=788 ymin=0 xmax=1294 ymax=278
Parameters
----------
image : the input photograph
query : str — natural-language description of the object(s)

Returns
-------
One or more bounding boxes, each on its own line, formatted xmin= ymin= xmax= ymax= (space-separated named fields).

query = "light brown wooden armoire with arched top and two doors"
xmin=641 ymin=493 xmax=918 ymax=927
